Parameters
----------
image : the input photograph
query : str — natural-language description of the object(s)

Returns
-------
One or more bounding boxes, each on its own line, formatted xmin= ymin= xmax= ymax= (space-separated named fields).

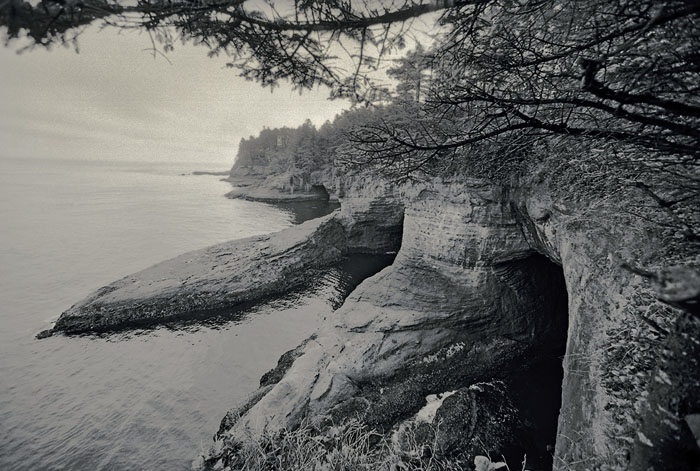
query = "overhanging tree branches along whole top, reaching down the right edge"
xmin=0 ymin=0 xmax=700 ymax=234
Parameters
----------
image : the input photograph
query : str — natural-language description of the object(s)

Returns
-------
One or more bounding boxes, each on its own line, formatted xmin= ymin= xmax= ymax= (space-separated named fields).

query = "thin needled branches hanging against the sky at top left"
xmin=0 ymin=0 xmax=454 ymax=100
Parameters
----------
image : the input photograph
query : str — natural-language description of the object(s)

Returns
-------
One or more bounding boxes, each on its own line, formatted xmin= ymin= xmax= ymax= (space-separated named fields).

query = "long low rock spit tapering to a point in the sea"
xmin=39 ymin=175 xmax=403 ymax=338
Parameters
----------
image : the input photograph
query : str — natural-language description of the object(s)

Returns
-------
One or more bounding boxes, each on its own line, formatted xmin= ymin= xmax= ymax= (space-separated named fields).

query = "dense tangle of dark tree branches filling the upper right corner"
xmin=344 ymin=0 xmax=700 ymax=165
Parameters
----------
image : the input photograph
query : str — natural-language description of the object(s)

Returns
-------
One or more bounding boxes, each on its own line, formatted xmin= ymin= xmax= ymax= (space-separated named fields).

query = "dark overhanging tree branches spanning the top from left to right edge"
xmin=8 ymin=0 xmax=700 ymax=160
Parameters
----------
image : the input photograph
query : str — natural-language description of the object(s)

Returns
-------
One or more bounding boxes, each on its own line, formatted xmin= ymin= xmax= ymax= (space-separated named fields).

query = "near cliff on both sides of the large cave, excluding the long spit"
xmin=207 ymin=175 xmax=698 ymax=470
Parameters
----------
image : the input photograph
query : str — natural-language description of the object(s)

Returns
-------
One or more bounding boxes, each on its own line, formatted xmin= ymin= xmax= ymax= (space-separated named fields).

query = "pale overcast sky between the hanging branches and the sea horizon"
xmin=0 ymin=28 xmax=349 ymax=166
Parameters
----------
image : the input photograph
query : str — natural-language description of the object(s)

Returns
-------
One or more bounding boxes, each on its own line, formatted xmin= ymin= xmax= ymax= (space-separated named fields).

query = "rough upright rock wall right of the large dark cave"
xmin=516 ymin=182 xmax=700 ymax=470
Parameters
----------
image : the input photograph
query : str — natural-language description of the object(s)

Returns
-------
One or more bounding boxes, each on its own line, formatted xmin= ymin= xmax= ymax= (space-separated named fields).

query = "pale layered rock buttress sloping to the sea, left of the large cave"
xmin=211 ymin=178 xmax=567 ymax=468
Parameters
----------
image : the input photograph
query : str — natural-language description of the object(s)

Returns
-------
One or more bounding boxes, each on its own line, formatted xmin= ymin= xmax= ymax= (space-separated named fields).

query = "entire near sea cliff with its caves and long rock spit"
xmin=46 ymin=168 xmax=700 ymax=470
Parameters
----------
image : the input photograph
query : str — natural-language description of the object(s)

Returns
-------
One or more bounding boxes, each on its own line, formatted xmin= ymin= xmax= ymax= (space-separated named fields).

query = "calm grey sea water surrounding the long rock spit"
xmin=0 ymin=159 xmax=374 ymax=470
